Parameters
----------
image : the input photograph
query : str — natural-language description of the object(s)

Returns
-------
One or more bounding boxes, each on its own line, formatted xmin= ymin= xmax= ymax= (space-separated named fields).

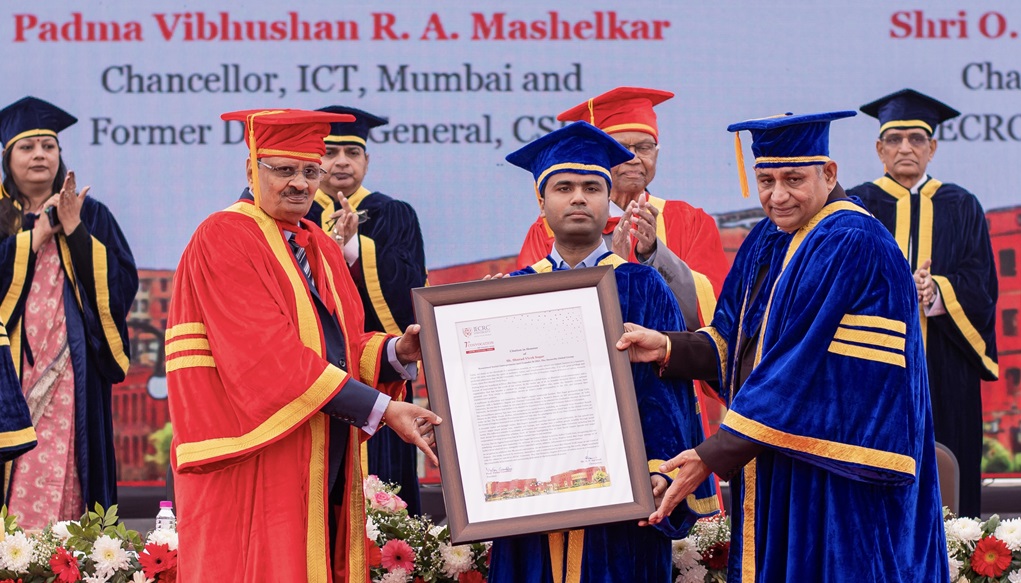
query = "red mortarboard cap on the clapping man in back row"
xmin=556 ymin=87 xmax=674 ymax=142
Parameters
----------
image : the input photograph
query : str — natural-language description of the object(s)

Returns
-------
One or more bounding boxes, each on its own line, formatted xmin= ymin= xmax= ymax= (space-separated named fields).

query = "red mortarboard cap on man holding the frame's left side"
xmin=220 ymin=109 xmax=354 ymax=163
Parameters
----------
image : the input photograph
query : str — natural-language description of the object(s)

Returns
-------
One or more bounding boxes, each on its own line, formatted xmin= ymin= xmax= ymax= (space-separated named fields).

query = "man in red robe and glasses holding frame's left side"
xmin=166 ymin=110 xmax=438 ymax=583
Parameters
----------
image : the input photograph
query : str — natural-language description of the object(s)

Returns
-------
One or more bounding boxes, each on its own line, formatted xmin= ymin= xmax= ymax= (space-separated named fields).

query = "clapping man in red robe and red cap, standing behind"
xmin=518 ymin=87 xmax=727 ymax=330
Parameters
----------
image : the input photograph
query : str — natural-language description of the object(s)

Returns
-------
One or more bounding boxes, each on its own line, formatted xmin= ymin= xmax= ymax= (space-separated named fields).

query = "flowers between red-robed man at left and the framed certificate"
xmin=363 ymin=476 xmax=489 ymax=583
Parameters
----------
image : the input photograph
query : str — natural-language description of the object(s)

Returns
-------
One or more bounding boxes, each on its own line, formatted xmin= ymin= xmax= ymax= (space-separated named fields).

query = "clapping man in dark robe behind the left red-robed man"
xmin=305 ymin=105 xmax=426 ymax=515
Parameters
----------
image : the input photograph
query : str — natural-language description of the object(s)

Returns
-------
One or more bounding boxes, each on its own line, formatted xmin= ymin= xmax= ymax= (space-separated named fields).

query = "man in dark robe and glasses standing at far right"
xmin=847 ymin=89 xmax=1000 ymax=517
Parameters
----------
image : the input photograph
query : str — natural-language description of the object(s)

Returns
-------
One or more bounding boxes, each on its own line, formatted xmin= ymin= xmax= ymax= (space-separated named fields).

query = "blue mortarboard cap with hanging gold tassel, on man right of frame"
xmin=727 ymin=110 xmax=858 ymax=197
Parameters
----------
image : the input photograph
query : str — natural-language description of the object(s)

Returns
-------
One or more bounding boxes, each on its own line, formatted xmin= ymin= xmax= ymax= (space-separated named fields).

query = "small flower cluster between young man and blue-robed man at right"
xmin=673 ymin=514 xmax=730 ymax=583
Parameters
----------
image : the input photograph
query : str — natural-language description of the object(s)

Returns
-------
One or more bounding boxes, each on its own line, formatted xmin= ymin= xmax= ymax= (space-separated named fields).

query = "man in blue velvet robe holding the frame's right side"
xmin=618 ymin=111 xmax=949 ymax=583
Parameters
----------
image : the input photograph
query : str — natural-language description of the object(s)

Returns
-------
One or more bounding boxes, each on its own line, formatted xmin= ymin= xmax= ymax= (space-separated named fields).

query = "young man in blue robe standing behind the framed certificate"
xmin=489 ymin=122 xmax=719 ymax=583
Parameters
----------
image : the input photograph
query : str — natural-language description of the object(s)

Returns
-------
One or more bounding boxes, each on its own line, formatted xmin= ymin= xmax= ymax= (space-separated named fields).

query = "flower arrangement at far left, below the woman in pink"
xmin=0 ymin=504 xmax=178 ymax=583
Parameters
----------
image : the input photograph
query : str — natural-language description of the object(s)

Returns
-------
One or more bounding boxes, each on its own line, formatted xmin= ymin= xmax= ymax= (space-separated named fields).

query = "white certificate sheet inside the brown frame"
xmin=435 ymin=288 xmax=634 ymax=522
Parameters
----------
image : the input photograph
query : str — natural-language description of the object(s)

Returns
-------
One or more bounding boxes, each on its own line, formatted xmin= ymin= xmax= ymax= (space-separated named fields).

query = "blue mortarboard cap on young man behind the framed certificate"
xmin=506 ymin=122 xmax=634 ymax=198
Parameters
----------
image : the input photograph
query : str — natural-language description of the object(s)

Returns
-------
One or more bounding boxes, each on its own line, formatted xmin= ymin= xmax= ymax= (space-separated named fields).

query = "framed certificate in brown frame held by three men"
xmin=412 ymin=266 xmax=654 ymax=544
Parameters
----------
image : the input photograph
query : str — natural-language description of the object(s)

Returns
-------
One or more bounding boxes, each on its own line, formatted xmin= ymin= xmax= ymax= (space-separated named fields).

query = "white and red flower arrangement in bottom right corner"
xmin=943 ymin=506 xmax=1021 ymax=583
